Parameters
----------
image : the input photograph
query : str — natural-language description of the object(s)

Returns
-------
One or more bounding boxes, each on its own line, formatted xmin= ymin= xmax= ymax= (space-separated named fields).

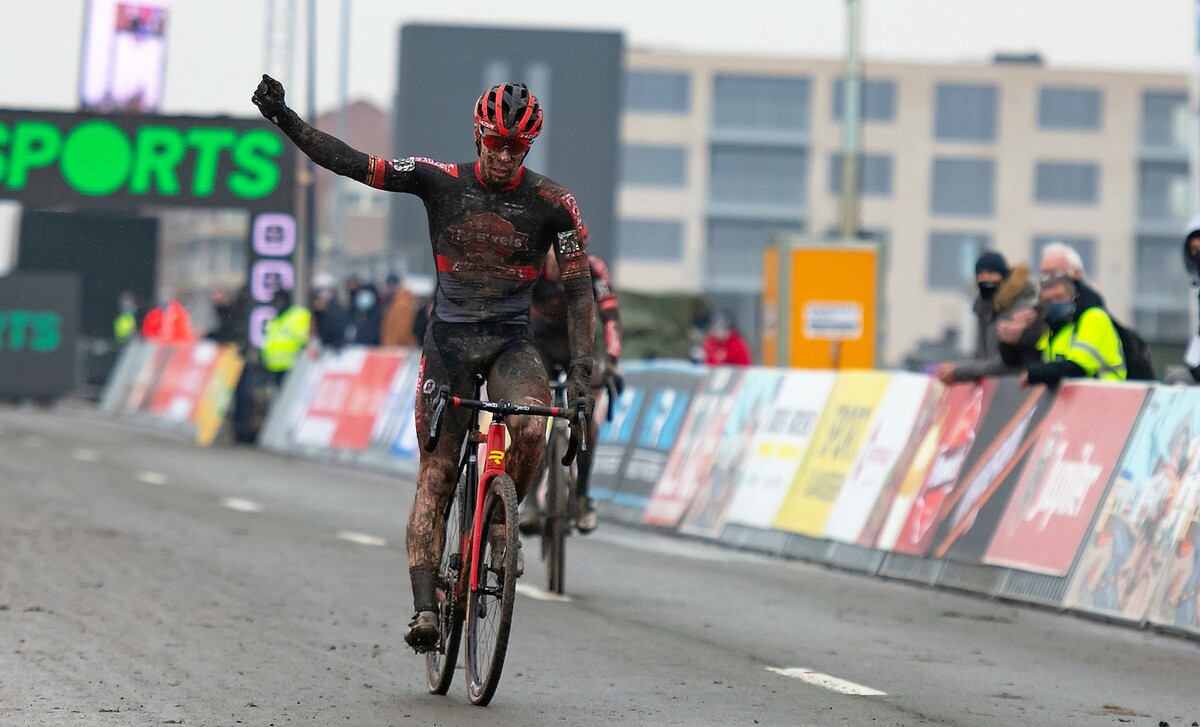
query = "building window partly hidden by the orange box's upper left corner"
xmin=704 ymin=220 xmax=803 ymax=292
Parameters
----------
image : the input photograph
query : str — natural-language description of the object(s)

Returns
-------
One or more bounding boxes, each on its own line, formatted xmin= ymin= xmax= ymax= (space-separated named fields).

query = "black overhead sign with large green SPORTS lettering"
xmin=0 ymin=110 xmax=295 ymax=210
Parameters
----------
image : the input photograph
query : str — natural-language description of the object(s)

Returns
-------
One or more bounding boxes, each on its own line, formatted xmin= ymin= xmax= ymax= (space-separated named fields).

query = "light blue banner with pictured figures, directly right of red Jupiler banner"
xmin=1064 ymin=387 xmax=1200 ymax=620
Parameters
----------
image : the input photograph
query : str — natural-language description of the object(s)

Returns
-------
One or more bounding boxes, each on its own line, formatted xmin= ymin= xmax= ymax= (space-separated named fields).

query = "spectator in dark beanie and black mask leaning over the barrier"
xmin=937 ymin=252 xmax=1038 ymax=384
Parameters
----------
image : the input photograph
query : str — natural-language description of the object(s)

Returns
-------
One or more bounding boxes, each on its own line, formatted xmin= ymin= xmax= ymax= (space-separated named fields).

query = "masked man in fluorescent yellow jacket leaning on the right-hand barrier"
xmin=1001 ymin=277 xmax=1127 ymax=386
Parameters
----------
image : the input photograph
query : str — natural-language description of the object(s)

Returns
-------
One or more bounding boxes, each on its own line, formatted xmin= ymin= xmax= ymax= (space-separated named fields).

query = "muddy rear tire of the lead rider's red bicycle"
xmin=425 ymin=467 xmax=469 ymax=695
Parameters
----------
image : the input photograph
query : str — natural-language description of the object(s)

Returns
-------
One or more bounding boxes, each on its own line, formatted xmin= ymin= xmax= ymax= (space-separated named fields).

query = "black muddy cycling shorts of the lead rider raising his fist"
xmin=416 ymin=319 xmax=550 ymax=461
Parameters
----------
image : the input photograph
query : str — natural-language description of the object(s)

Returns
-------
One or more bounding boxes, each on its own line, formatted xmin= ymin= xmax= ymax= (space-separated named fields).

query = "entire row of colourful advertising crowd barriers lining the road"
xmin=102 ymin=343 xmax=1200 ymax=636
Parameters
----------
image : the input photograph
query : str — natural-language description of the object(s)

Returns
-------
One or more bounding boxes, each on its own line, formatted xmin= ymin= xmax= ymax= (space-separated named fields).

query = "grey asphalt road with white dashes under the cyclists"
xmin=0 ymin=404 xmax=1200 ymax=727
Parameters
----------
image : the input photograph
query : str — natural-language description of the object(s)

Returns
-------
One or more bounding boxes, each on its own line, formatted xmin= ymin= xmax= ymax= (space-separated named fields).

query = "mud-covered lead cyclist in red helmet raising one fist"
xmin=252 ymin=74 xmax=595 ymax=653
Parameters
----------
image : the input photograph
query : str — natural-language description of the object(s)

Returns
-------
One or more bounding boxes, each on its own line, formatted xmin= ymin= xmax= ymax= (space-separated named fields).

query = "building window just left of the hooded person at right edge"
xmin=1133 ymin=235 xmax=1194 ymax=343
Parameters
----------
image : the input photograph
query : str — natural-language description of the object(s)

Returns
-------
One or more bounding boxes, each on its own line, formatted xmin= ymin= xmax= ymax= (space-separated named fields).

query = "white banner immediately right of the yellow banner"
xmin=824 ymin=372 xmax=931 ymax=543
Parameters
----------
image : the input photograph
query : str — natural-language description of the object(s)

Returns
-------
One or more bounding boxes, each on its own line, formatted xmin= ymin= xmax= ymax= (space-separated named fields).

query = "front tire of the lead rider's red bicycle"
xmin=466 ymin=475 xmax=521 ymax=707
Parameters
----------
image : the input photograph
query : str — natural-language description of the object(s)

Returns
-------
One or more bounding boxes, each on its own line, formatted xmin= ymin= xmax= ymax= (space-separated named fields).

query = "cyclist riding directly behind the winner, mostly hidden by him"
xmin=521 ymin=254 xmax=624 ymax=535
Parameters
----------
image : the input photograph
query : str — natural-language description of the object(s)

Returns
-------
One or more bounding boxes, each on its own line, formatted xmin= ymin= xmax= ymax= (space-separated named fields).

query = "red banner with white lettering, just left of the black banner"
xmin=880 ymin=379 xmax=996 ymax=555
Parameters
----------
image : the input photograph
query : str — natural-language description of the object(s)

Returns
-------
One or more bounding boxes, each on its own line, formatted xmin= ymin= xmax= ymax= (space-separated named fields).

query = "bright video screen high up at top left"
xmin=79 ymin=0 xmax=169 ymax=114
